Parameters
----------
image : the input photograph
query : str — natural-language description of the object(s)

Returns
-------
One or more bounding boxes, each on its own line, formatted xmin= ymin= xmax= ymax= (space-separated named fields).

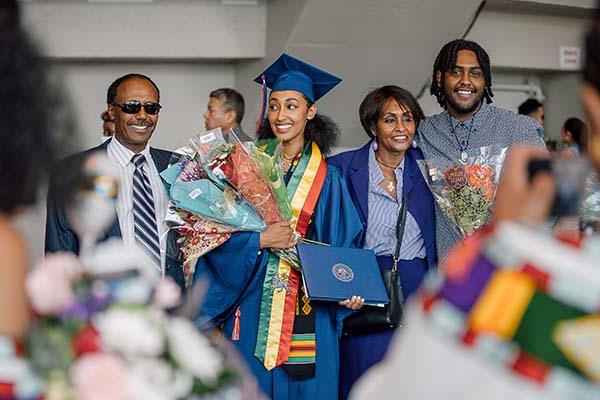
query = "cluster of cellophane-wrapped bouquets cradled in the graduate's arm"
xmin=161 ymin=128 xmax=299 ymax=287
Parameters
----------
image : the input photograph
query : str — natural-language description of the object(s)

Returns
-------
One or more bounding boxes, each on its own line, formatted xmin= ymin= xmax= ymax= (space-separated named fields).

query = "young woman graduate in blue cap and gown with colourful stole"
xmin=196 ymin=54 xmax=364 ymax=400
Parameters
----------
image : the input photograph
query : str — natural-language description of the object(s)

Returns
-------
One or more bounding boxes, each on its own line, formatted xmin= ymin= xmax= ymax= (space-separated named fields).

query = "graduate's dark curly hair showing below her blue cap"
xmin=256 ymin=114 xmax=341 ymax=156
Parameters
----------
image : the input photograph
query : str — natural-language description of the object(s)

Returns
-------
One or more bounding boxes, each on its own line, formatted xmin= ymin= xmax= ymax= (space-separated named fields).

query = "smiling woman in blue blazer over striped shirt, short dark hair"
xmin=328 ymin=86 xmax=437 ymax=398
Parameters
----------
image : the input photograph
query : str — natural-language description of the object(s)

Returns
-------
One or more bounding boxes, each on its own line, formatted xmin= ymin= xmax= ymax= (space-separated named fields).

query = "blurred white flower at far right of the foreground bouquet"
xmin=167 ymin=318 xmax=223 ymax=381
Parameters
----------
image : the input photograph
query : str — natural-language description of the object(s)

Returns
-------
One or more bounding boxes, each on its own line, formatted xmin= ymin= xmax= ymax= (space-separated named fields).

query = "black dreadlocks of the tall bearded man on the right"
xmin=429 ymin=39 xmax=494 ymax=108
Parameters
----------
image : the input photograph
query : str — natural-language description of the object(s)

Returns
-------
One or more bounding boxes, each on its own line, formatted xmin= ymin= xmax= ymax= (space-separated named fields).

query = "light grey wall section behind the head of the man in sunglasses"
xmin=53 ymin=62 xmax=235 ymax=150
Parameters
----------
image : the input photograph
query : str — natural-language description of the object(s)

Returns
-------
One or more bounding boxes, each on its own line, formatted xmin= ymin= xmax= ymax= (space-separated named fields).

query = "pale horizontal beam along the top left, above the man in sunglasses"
xmin=23 ymin=0 xmax=266 ymax=59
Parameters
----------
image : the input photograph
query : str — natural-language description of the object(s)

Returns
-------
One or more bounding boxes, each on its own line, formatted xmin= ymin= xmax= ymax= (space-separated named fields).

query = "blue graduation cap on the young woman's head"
xmin=254 ymin=53 xmax=342 ymax=103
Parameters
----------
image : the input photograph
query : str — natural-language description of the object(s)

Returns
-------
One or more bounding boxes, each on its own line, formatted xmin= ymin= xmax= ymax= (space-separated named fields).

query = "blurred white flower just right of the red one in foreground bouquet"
xmin=94 ymin=308 xmax=165 ymax=356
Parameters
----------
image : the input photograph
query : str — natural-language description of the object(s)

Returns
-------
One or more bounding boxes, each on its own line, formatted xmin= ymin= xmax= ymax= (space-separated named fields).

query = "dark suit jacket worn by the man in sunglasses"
xmin=45 ymin=140 xmax=183 ymax=282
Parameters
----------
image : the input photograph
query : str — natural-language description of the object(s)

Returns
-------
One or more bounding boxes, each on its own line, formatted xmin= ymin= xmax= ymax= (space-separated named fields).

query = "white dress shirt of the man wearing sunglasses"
xmin=107 ymin=137 xmax=168 ymax=275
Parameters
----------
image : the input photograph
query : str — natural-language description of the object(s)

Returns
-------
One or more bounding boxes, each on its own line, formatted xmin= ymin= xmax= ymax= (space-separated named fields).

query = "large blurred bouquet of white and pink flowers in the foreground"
xmin=25 ymin=247 xmax=243 ymax=400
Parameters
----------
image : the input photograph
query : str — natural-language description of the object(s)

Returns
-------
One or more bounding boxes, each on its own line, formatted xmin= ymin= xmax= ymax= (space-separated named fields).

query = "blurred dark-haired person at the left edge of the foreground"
xmin=0 ymin=0 xmax=64 ymax=399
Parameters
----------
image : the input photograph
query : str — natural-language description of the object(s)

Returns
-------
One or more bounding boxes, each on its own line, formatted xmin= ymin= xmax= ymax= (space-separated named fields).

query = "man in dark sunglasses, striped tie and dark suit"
xmin=46 ymin=74 xmax=180 ymax=284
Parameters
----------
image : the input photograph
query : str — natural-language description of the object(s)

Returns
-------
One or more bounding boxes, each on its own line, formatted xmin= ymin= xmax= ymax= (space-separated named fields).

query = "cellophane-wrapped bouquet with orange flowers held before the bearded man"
xmin=419 ymin=146 xmax=507 ymax=236
